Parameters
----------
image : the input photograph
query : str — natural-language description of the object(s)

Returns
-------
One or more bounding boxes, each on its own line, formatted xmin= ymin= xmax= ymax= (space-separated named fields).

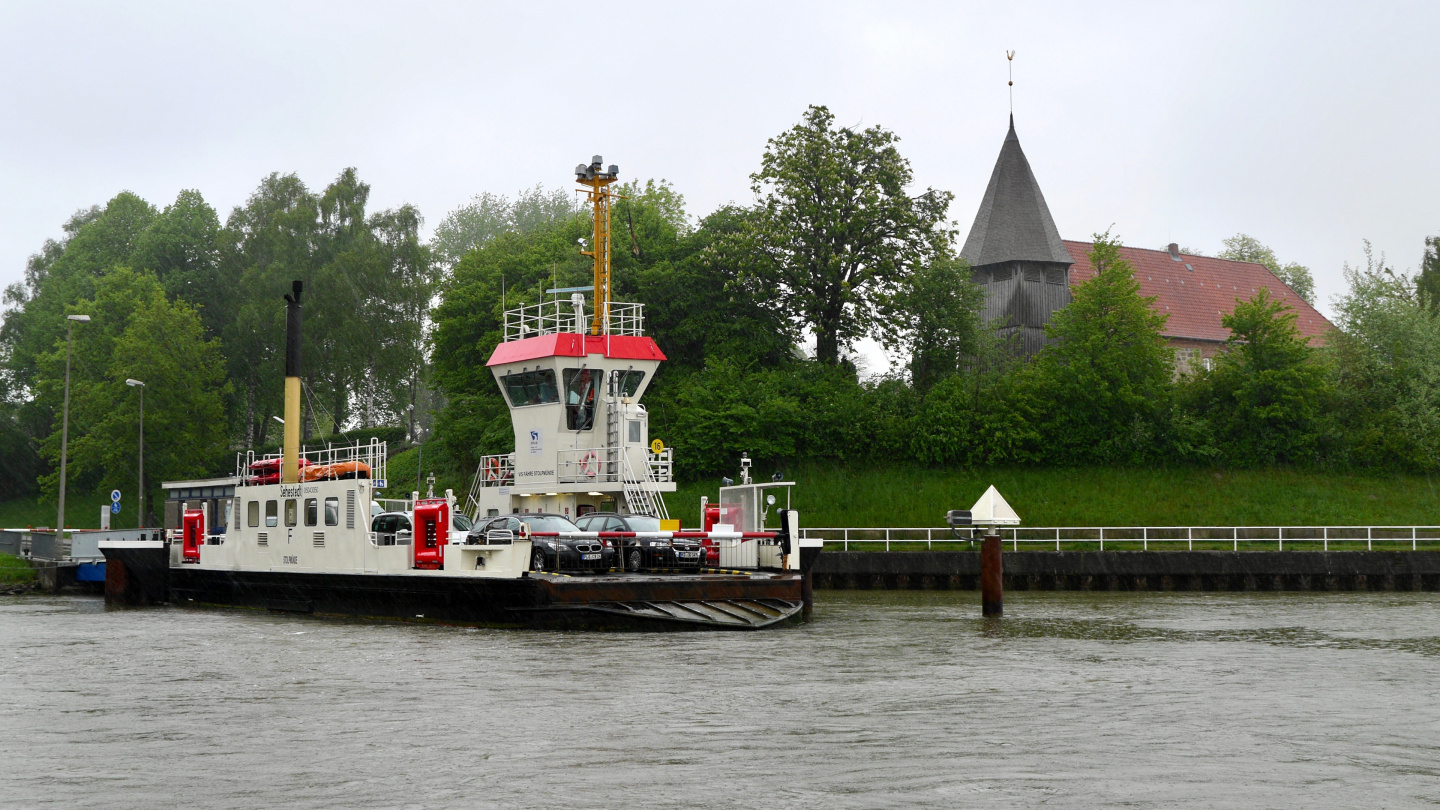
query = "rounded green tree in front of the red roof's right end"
xmin=1210 ymin=287 xmax=1331 ymax=466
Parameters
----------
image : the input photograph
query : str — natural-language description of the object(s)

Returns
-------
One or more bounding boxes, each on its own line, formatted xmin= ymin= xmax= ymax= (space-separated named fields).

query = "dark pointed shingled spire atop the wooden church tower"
xmin=960 ymin=114 xmax=1071 ymax=267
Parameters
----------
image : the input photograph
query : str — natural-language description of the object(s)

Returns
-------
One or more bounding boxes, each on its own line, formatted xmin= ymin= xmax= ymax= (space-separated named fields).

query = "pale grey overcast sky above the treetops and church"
xmin=0 ymin=0 xmax=1440 ymax=366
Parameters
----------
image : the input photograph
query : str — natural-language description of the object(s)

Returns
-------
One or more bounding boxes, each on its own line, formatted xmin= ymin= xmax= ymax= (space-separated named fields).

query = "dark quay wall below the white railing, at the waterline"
xmin=815 ymin=549 xmax=1440 ymax=591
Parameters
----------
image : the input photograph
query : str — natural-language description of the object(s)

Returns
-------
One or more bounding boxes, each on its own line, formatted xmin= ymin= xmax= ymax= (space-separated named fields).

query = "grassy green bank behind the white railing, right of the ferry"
xmin=667 ymin=464 xmax=1440 ymax=526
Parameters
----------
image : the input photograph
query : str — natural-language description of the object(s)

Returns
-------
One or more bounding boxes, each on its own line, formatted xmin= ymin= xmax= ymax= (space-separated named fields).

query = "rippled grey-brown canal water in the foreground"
xmin=0 ymin=591 xmax=1440 ymax=809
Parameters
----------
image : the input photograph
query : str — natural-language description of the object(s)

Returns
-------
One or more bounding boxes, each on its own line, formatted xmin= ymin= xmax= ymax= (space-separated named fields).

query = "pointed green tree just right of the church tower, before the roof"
xmin=1021 ymin=232 xmax=1175 ymax=463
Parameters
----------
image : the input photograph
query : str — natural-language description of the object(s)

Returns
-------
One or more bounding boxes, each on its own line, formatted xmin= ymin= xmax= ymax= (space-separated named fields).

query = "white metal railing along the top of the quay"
xmin=801 ymin=526 xmax=1440 ymax=551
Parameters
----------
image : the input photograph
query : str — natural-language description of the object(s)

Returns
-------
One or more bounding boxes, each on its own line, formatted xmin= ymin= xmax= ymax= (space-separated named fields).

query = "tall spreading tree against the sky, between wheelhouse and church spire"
xmin=716 ymin=107 xmax=953 ymax=365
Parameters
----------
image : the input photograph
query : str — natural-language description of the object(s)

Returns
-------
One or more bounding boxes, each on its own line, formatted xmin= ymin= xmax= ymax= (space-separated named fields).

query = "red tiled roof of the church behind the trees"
xmin=1066 ymin=239 xmax=1335 ymax=344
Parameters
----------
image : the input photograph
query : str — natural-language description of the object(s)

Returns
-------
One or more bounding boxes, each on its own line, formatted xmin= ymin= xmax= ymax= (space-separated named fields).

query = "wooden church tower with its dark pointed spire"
xmin=960 ymin=114 xmax=1073 ymax=357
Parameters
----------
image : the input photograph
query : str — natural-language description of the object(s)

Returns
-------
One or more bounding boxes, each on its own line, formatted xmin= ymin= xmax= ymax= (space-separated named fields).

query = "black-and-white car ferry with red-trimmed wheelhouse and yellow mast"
xmin=101 ymin=157 xmax=819 ymax=630
